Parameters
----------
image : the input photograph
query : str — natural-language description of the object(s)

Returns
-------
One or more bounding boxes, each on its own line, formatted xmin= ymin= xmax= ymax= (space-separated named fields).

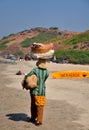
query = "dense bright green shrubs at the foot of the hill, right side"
xmin=54 ymin=50 xmax=89 ymax=64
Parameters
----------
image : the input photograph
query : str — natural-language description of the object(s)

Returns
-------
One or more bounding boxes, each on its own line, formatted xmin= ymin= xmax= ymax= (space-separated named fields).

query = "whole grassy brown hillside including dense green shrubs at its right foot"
xmin=0 ymin=28 xmax=89 ymax=64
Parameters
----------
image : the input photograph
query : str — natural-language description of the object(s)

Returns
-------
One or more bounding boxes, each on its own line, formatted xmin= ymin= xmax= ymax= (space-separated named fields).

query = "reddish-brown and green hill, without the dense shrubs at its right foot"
xmin=0 ymin=27 xmax=89 ymax=64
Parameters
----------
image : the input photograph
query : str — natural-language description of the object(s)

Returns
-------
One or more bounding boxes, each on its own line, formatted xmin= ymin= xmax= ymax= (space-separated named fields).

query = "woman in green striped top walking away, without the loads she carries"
xmin=25 ymin=59 xmax=49 ymax=125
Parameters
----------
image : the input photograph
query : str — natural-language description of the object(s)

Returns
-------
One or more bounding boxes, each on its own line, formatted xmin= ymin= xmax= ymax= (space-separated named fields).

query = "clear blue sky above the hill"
xmin=0 ymin=0 xmax=89 ymax=39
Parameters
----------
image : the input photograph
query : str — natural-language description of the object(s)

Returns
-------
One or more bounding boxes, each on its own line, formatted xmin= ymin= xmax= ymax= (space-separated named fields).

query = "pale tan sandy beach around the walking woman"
xmin=0 ymin=58 xmax=89 ymax=130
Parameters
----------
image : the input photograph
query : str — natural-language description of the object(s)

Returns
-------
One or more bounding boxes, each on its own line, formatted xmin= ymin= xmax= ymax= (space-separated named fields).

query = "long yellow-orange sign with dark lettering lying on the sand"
xmin=52 ymin=70 xmax=89 ymax=79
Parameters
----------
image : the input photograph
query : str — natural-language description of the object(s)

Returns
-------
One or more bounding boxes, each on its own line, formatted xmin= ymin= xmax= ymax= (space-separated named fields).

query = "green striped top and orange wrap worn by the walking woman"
xmin=26 ymin=67 xmax=49 ymax=106
